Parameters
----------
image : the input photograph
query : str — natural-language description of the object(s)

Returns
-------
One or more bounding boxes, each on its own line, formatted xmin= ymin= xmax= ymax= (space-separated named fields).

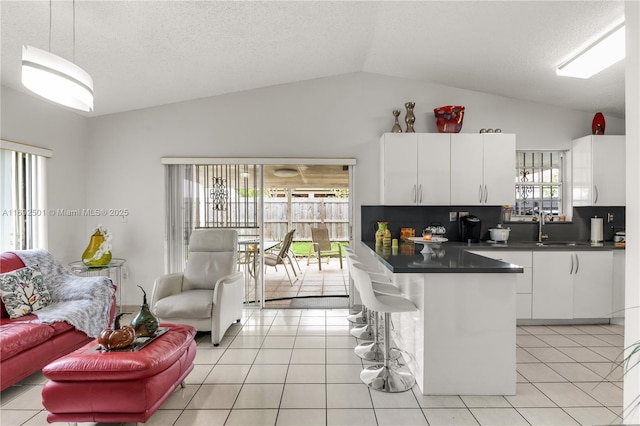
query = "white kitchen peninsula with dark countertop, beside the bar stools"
xmin=362 ymin=242 xmax=523 ymax=395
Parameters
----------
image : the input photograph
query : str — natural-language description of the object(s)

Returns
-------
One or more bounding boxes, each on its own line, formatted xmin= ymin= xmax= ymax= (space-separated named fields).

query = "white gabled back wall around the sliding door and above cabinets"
xmin=81 ymin=73 xmax=624 ymax=304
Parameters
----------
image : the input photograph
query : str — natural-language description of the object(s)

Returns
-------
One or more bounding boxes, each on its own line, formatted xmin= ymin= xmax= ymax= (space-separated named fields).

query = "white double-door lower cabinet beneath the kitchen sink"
xmin=532 ymin=250 xmax=613 ymax=319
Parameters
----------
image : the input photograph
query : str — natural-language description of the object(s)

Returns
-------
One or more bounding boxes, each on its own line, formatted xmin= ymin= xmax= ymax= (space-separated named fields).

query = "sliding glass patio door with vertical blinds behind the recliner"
xmin=163 ymin=159 xmax=354 ymax=308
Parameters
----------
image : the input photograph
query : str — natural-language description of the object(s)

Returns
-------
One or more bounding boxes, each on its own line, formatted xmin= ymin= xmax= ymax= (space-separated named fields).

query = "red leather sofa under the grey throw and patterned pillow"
xmin=0 ymin=252 xmax=116 ymax=390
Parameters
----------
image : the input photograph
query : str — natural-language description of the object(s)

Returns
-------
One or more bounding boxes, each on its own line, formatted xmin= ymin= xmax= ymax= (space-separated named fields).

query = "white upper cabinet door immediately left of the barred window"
xmin=481 ymin=133 xmax=516 ymax=206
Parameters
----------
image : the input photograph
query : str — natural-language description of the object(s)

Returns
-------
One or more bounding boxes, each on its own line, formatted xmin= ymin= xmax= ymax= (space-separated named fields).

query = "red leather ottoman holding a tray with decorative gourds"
xmin=42 ymin=324 xmax=196 ymax=423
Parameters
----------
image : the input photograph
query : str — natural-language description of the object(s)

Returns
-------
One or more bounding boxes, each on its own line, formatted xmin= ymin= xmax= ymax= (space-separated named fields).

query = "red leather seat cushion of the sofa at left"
xmin=0 ymin=321 xmax=55 ymax=360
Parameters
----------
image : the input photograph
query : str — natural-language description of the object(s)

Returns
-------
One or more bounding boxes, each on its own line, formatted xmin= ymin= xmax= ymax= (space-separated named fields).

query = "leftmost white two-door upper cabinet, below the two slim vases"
xmin=380 ymin=133 xmax=451 ymax=206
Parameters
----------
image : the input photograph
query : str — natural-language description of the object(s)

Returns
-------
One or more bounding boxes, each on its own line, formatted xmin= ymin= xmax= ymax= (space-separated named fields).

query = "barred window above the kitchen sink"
xmin=511 ymin=150 xmax=568 ymax=221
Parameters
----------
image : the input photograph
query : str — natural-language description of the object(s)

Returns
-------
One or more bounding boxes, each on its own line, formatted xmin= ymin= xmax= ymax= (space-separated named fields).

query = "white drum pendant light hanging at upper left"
xmin=22 ymin=0 xmax=93 ymax=112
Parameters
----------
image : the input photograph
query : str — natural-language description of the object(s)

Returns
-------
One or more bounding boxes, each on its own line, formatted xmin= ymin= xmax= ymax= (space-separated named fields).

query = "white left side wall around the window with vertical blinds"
xmin=0 ymin=86 xmax=91 ymax=265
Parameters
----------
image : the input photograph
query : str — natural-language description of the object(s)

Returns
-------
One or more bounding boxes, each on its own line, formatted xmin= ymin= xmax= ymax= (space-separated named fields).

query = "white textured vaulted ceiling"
xmin=0 ymin=0 xmax=624 ymax=118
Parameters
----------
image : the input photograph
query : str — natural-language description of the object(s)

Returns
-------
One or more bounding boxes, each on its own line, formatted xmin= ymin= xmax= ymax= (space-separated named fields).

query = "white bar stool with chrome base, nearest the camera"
xmin=353 ymin=264 xmax=417 ymax=392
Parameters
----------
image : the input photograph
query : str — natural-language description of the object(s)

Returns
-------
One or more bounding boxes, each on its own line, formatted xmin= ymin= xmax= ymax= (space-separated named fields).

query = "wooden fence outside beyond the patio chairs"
xmin=263 ymin=197 xmax=349 ymax=241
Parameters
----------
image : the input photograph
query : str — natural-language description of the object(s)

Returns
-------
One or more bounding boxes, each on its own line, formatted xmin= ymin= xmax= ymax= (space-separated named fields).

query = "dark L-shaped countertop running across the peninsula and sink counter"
xmin=361 ymin=241 xmax=624 ymax=274
